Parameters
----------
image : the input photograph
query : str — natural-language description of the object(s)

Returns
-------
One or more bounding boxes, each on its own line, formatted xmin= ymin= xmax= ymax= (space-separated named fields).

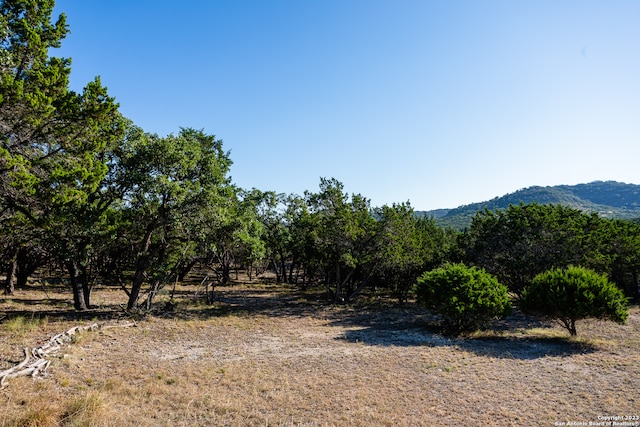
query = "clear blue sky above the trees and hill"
xmin=52 ymin=0 xmax=640 ymax=210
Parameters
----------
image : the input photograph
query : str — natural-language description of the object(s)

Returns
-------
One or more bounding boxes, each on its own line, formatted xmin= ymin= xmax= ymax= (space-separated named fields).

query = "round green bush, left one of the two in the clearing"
xmin=414 ymin=264 xmax=511 ymax=335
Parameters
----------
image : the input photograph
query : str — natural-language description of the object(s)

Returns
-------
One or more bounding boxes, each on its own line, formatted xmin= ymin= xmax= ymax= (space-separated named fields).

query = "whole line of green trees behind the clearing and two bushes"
xmin=0 ymin=0 xmax=640 ymax=328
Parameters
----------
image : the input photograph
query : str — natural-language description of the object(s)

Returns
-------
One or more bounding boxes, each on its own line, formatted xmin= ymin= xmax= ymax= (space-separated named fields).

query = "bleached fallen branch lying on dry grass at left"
xmin=0 ymin=322 xmax=136 ymax=389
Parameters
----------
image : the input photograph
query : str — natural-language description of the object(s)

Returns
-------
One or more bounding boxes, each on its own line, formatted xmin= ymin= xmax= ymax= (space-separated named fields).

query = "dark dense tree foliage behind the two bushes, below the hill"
xmin=460 ymin=203 xmax=640 ymax=297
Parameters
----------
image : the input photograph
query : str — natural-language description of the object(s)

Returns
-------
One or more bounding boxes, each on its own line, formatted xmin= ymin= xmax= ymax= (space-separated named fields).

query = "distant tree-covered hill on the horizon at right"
xmin=416 ymin=181 xmax=640 ymax=230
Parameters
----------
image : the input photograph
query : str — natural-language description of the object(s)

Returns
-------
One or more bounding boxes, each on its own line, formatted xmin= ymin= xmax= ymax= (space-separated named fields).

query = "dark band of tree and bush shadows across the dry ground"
xmin=0 ymin=286 xmax=598 ymax=360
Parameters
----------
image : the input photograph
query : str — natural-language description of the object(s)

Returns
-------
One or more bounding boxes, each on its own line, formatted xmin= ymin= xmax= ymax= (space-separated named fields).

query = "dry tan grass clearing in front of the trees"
xmin=0 ymin=280 xmax=640 ymax=426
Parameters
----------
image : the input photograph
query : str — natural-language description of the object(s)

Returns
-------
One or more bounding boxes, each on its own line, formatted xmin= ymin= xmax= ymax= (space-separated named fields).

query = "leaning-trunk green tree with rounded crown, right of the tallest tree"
xmin=118 ymin=129 xmax=231 ymax=309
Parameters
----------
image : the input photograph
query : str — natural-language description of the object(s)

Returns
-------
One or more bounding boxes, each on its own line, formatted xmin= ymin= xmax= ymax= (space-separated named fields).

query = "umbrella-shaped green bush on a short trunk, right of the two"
xmin=520 ymin=267 xmax=629 ymax=335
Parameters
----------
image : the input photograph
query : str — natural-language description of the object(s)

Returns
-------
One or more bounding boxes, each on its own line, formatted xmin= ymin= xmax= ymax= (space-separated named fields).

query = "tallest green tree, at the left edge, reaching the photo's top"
xmin=0 ymin=0 xmax=122 ymax=309
